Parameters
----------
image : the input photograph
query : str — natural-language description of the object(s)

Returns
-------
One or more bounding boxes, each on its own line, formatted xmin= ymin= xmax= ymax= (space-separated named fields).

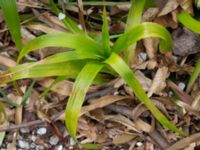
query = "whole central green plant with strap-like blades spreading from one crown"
xmin=0 ymin=0 xmax=186 ymax=140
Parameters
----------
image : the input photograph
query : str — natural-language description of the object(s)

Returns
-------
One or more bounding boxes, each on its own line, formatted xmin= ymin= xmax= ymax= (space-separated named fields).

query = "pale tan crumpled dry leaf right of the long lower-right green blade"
xmin=148 ymin=67 xmax=169 ymax=97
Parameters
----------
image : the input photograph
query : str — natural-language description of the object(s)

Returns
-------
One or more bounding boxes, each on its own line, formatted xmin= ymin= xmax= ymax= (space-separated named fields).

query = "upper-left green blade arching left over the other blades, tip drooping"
xmin=17 ymin=33 xmax=103 ymax=62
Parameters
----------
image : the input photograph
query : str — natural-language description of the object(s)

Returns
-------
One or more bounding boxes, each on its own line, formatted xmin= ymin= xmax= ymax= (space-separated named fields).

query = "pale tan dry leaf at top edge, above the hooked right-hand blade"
xmin=158 ymin=0 xmax=179 ymax=16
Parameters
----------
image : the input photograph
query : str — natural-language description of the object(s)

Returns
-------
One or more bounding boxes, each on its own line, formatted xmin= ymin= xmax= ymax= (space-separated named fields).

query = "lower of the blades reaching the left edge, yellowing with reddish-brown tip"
xmin=0 ymin=60 xmax=85 ymax=84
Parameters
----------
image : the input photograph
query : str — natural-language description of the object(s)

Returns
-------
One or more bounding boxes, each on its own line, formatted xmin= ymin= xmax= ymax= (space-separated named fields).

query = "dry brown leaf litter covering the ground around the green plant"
xmin=0 ymin=0 xmax=200 ymax=150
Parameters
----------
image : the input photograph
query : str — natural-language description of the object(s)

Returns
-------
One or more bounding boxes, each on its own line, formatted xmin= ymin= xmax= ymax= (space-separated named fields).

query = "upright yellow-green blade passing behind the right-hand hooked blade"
xmin=124 ymin=0 xmax=146 ymax=65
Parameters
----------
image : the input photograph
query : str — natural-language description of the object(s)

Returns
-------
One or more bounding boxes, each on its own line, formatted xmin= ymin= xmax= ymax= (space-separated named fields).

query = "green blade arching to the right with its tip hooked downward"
xmin=112 ymin=22 xmax=172 ymax=53
